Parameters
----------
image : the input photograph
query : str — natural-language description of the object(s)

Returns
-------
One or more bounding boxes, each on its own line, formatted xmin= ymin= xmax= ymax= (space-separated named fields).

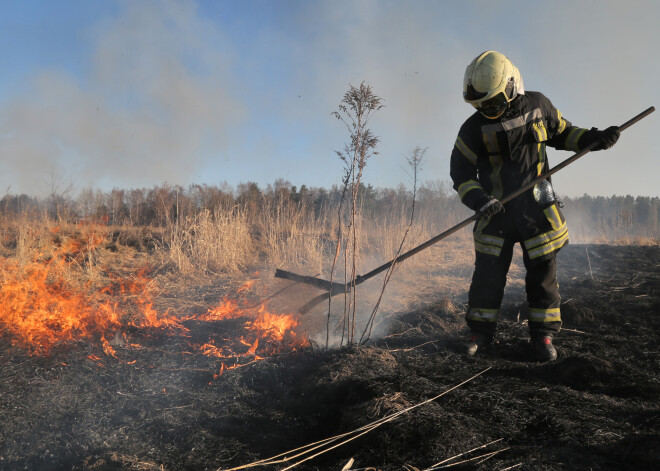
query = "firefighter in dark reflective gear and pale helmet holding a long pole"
xmin=451 ymin=51 xmax=619 ymax=361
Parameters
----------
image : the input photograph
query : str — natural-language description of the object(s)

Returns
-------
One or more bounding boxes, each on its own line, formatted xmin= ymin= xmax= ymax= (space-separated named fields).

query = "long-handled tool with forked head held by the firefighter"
xmin=275 ymin=106 xmax=655 ymax=314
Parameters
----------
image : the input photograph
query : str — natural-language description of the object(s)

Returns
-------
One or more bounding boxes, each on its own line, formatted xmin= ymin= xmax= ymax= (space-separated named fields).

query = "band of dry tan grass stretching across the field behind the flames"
xmin=0 ymin=201 xmax=658 ymax=326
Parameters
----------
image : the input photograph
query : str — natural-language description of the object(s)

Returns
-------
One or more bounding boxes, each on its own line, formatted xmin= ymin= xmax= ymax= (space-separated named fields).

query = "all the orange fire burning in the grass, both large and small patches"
xmin=0 ymin=226 xmax=309 ymax=374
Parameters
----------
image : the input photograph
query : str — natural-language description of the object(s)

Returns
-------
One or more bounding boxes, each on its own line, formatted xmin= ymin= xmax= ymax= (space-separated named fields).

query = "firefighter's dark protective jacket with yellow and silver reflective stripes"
xmin=451 ymin=91 xmax=588 ymax=260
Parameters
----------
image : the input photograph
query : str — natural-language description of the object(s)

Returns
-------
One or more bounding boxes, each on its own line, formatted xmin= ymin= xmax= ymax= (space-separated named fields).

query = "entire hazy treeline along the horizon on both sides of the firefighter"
xmin=0 ymin=179 xmax=660 ymax=242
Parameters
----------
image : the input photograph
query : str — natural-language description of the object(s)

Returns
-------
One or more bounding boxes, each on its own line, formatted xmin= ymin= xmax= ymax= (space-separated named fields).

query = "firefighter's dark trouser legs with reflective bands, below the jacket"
xmin=466 ymin=240 xmax=561 ymax=337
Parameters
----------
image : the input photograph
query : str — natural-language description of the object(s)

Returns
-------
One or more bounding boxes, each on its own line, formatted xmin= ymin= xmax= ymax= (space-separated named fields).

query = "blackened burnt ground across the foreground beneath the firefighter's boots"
xmin=0 ymin=245 xmax=660 ymax=471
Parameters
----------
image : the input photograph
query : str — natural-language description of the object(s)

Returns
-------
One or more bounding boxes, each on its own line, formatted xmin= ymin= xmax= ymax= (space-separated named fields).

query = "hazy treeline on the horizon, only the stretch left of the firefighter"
xmin=0 ymin=179 xmax=465 ymax=227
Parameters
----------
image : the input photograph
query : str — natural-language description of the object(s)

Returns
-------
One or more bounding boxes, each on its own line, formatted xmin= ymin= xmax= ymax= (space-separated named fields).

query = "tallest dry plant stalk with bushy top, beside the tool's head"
xmin=332 ymin=82 xmax=385 ymax=345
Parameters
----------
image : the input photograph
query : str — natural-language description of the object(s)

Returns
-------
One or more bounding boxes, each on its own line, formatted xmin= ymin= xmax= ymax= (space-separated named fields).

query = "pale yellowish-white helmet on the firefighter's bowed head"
xmin=463 ymin=51 xmax=525 ymax=119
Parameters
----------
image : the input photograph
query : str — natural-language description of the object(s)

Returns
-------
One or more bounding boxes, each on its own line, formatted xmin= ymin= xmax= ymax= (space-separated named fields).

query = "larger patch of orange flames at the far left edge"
xmin=0 ymin=226 xmax=185 ymax=354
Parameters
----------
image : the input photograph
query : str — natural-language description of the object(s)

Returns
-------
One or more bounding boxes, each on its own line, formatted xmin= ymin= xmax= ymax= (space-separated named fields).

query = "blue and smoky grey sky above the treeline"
xmin=0 ymin=0 xmax=660 ymax=197
